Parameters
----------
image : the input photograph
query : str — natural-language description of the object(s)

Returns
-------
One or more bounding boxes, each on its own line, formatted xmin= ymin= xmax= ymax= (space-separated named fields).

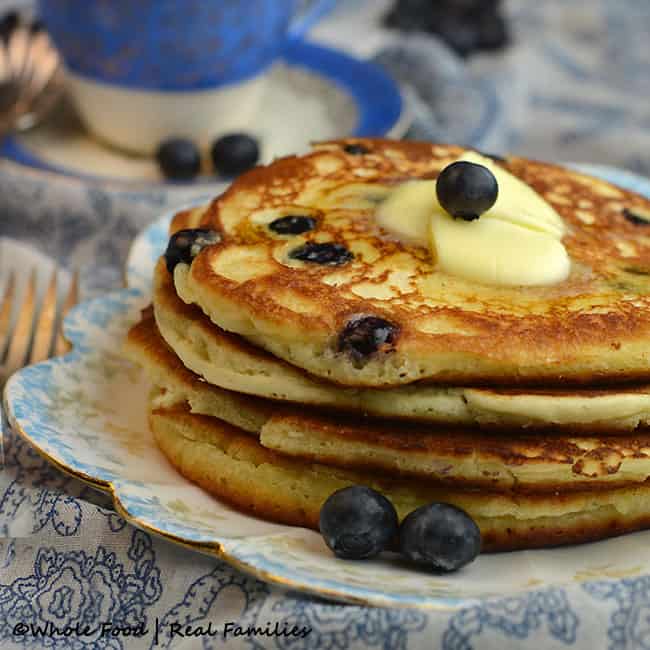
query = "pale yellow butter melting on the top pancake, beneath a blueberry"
xmin=377 ymin=152 xmax=571 ymax=286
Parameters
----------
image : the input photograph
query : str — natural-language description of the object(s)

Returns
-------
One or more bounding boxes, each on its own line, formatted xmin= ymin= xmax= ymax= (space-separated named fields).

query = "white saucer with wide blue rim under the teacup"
xmin=0 ymin=41 xmax=407 ymax=190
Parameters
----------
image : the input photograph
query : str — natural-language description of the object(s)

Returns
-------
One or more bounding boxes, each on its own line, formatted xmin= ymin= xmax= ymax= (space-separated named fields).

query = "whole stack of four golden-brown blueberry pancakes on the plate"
xmin=126 ymin=139 xmax=650 ymax=550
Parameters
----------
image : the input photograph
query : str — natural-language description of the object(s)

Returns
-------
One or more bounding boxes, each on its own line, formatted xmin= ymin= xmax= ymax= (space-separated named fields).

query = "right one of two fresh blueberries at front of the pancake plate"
xmin=399 ymin=503 xmax=481 ymax=573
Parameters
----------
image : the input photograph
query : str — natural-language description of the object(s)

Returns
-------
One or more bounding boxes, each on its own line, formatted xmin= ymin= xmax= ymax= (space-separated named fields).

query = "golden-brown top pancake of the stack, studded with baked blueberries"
xmin=174 ymin=140 xmax=650 ymax=387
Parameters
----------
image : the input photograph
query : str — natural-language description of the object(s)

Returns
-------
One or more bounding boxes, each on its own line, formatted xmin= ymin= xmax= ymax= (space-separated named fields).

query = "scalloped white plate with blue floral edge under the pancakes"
xmin=5 ymin=166 xmax=650 ymax=609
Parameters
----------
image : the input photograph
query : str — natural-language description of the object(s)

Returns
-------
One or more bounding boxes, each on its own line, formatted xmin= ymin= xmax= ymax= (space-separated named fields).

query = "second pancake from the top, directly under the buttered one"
xmin=153 ymin=256 xmax=650 ymax=433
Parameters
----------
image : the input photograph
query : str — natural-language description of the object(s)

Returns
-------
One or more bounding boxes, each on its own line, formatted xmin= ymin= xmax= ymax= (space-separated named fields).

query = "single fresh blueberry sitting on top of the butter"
xmin=436 ymin=161 xmax=499 ymax=221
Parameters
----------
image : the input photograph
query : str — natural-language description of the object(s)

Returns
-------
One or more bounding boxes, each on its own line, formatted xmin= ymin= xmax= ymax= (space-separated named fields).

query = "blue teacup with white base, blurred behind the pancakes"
xmin=39 ymin=0 xmax=336 ymax=154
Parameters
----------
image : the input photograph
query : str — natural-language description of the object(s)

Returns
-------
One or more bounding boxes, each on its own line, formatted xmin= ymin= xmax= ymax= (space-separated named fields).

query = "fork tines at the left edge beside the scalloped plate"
xmin=0 ymin=269 xmax=79 ymax=386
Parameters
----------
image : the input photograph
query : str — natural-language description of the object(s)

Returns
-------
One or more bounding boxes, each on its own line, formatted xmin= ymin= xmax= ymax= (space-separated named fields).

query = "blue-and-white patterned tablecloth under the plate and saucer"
xmin=0 ymin=0 xmax=650 ymax=650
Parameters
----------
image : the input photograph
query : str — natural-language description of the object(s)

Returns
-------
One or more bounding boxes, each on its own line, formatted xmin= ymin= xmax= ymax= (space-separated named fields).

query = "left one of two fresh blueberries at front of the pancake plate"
xmin=319 ymin=485 xmax=398 ymax=560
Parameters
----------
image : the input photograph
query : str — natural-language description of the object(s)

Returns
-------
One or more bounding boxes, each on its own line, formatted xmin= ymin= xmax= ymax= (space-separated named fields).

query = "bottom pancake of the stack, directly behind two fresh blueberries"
xmin=149 ymin=408 xmax=650 ymax=552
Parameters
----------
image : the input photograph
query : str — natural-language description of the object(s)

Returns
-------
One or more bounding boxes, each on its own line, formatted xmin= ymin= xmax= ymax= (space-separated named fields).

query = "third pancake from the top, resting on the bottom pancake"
xmin=125 ymin=313 xmax=650 ymax=493
